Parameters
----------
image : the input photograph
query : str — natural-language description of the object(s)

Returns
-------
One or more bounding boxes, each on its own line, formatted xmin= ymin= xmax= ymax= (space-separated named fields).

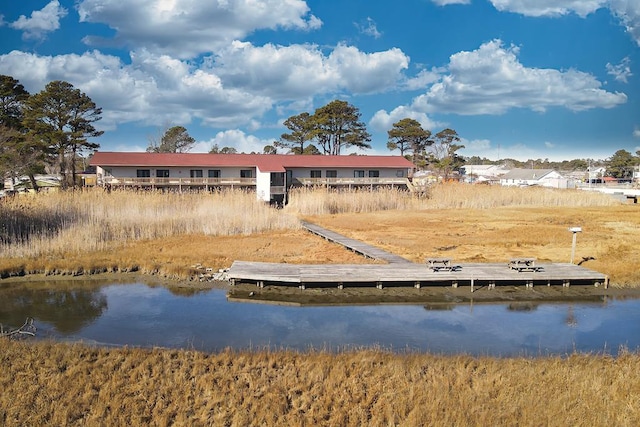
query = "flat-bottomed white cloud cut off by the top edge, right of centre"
xmin=490 ymin=0 xmax=607 ymax=17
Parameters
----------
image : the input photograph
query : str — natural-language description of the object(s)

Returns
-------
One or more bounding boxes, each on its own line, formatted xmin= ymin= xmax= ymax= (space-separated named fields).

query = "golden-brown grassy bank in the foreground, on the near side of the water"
xmin=0 ymin=341 xmax=640 ymax=426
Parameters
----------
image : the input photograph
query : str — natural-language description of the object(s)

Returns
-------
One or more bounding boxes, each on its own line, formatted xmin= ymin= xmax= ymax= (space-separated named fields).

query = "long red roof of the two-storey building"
xmin=90 ymin=151 xmax=413 ymax=172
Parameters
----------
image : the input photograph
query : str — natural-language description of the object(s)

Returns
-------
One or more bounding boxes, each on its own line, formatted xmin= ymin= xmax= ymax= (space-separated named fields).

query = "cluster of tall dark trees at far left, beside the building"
xmin=0 ymin=75 xmax=103 ymax=190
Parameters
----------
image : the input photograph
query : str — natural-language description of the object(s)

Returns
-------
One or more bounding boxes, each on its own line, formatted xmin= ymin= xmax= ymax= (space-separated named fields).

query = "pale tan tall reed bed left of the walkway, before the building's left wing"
xmin=0 ymin=189 xmax=299 ymax=257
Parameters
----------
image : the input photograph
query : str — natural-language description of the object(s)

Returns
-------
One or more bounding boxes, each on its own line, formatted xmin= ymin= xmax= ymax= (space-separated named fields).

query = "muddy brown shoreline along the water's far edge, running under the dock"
xmin=0 ymin=272 xmax=640 ymax=309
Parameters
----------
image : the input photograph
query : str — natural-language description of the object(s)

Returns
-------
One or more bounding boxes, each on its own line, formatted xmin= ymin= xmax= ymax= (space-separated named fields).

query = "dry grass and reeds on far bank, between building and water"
xmin=0 ymin=184 xmax=640 ymax=286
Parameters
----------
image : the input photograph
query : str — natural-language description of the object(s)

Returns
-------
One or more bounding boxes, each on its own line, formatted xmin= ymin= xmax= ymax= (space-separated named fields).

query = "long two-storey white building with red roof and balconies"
xmin=91 ymin=151 xmax=413 ymax=203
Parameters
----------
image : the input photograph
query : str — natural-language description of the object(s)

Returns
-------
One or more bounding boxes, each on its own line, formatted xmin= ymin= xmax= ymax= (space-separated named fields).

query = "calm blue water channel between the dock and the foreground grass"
xmin=0 ymin=284 xmax=640 ymax=356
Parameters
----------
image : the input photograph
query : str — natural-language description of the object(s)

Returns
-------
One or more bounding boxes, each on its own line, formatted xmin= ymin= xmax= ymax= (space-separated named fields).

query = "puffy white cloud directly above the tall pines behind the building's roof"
xmin=215 ymin=41 xmax=409 ymax=96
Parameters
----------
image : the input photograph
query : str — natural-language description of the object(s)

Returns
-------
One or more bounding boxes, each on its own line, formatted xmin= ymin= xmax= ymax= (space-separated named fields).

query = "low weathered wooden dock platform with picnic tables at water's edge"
xmin=228 ymin=261 xmax=609 ymax=292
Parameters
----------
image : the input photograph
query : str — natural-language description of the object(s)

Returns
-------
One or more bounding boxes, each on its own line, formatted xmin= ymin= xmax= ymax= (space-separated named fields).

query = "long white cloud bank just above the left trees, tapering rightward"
xmin=0 ymin=51 xmax=272 ymax=129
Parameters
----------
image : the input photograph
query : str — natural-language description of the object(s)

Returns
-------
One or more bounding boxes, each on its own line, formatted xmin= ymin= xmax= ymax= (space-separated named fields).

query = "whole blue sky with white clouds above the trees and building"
xmin=0 ymin=0 xmax=640 ymax=160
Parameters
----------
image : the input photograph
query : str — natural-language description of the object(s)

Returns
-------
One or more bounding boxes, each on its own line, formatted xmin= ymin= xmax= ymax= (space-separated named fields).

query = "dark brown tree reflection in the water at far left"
xmin=0 ymin=286 xmax=107 ymax=334
